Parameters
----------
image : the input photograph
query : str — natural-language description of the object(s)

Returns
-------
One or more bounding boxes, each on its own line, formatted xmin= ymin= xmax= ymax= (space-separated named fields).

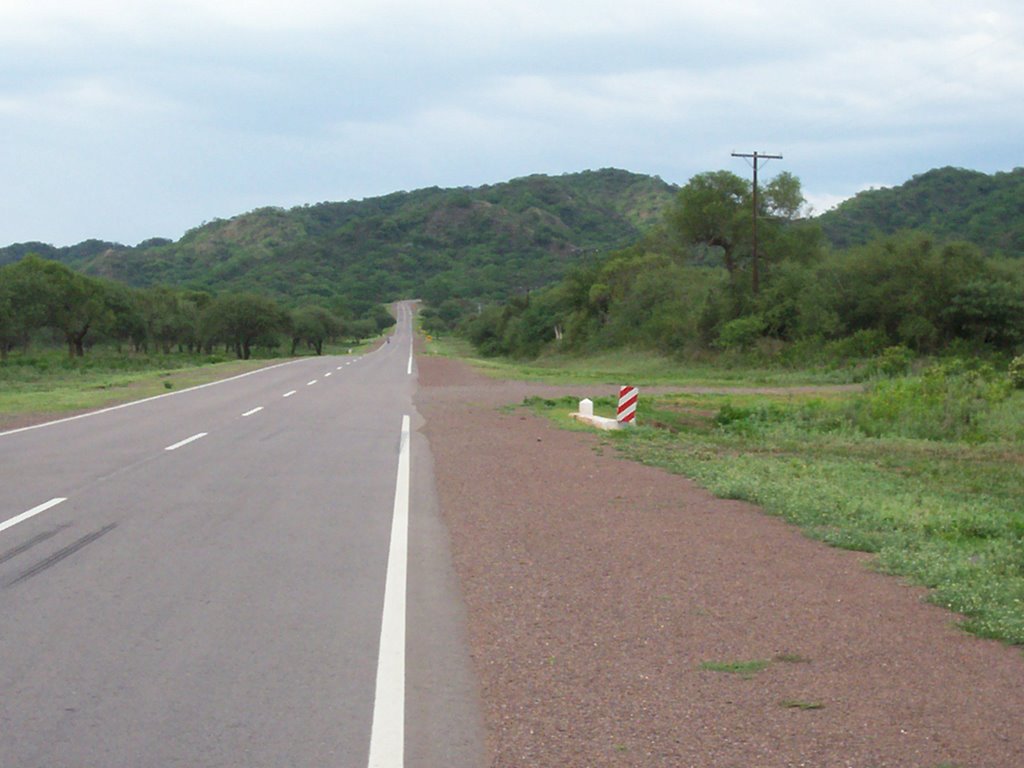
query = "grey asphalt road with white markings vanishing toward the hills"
xmin=0 ymin=303 xmax=483 ymax=768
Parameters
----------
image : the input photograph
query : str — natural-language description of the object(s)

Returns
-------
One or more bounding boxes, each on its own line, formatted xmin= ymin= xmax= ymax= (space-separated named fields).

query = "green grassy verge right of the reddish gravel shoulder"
xmin=421 ymin=335 xmax=1024 ymax=644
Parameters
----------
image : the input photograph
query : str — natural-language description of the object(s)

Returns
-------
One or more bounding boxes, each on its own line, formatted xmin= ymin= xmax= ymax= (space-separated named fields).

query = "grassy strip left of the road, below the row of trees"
xmin=0 ymin=342 xmax=374 ymax=431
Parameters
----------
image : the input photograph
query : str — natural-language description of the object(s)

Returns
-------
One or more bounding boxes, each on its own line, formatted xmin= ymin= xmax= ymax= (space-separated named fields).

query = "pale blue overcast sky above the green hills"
xmin=0 ymin=0 xmax=1024 ymax=246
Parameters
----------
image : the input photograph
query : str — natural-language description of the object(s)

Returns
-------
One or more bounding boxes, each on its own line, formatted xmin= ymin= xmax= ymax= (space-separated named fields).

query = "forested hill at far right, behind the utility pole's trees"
xmin=817 ymin=168 xmax=1024 ymax=257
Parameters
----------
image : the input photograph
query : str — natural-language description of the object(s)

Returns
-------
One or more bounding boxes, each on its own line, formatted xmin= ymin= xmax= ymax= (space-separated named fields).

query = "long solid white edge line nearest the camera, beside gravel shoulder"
xmin=370 ymin=416 xmax=410 ymax=768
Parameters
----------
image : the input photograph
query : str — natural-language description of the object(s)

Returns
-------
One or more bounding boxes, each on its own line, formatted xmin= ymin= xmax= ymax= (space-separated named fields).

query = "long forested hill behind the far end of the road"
xmin=0 ymin=169 xmax=676 ymax=302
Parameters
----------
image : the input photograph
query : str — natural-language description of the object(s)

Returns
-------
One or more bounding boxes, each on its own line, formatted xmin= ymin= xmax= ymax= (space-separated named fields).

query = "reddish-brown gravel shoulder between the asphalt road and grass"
xmin=417 ymin=357 xmax=1024 ymax=768
